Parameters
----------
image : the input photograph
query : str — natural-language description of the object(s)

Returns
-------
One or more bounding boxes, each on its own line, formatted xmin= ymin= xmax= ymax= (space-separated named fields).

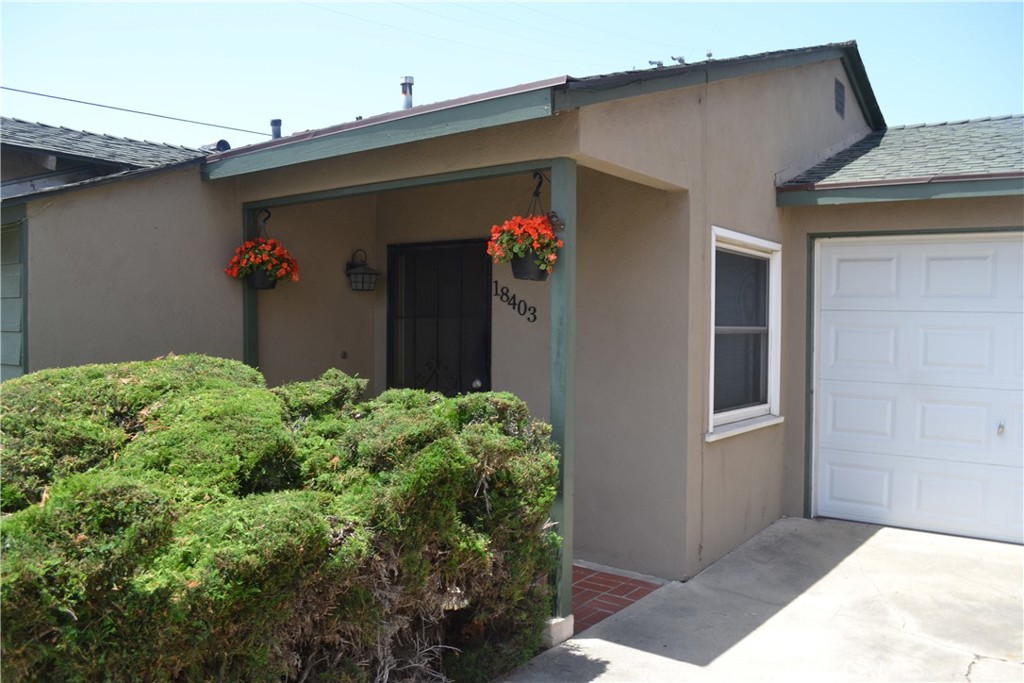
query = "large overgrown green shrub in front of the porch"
xmin=0 ymin=356 xmax=557 ymax=681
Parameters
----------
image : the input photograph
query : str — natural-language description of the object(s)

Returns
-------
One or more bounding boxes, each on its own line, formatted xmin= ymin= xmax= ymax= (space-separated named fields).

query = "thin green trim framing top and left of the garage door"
xmin=804 ymin=227 xmax=1024 ymax=519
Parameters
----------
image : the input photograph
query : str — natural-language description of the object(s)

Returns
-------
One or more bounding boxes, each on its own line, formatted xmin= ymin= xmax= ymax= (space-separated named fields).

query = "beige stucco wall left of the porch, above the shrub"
xmin=28 ymin=167 xmax=242 ymax=370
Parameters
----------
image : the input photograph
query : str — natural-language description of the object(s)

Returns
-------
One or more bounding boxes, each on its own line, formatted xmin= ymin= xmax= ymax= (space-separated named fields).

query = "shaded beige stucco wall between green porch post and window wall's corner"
xmin=574 ymin=169 xmax=690 ymax=577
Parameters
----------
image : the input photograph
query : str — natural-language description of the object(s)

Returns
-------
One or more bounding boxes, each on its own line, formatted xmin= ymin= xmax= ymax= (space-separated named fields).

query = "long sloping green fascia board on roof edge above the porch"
xmin=203 ymin=87 xmax=554 ymax=180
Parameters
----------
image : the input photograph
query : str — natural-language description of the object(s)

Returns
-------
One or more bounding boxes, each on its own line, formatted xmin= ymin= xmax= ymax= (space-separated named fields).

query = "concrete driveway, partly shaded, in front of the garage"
xmin=503 ymin=519 xmax=1024 ymax=683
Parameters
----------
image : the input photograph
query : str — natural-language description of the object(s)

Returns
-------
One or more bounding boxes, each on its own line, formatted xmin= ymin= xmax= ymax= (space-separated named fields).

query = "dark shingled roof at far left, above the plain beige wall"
xmin=0 ymin=117 xmax=207 ymax=168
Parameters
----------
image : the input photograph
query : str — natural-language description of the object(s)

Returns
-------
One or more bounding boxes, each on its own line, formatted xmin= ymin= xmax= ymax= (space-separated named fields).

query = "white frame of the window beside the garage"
xmin=707 ymin=225 xmax=782 ymax=441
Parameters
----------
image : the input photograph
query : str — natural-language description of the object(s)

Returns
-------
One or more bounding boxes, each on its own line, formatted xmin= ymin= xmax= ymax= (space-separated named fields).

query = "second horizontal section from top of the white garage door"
xmin=818 ymin=311 xmax=1024 ymax=389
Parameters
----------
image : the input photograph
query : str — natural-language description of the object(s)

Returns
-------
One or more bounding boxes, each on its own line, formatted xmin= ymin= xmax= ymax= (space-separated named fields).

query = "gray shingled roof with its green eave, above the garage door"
xmin=778 ymin=115 xmax=1024 ymax=206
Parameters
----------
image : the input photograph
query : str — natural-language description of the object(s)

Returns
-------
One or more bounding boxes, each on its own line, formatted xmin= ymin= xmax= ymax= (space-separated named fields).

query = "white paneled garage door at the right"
xmin=814 ymin=233 xmax=1024 ymax=543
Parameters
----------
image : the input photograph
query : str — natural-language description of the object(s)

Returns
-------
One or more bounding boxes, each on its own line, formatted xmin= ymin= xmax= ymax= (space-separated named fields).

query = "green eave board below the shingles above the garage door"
xmin=775 ymin=172 xmax=1024 ymax=207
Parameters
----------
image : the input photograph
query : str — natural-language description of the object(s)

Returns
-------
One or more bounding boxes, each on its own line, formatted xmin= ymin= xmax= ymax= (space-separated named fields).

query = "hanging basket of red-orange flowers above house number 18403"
xmin=487 ymin=211 xmax=563 ymax=281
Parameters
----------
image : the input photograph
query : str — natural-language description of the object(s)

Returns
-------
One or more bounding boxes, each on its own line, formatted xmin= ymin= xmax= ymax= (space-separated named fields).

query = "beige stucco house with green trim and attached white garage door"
xmin=5 ymin=42 xmax=1024 ymax=634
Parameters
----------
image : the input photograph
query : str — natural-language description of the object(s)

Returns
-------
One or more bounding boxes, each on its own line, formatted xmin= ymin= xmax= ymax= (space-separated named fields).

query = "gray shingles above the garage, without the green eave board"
xmin=782 ymin=115 xmax=1024 ymax=188
